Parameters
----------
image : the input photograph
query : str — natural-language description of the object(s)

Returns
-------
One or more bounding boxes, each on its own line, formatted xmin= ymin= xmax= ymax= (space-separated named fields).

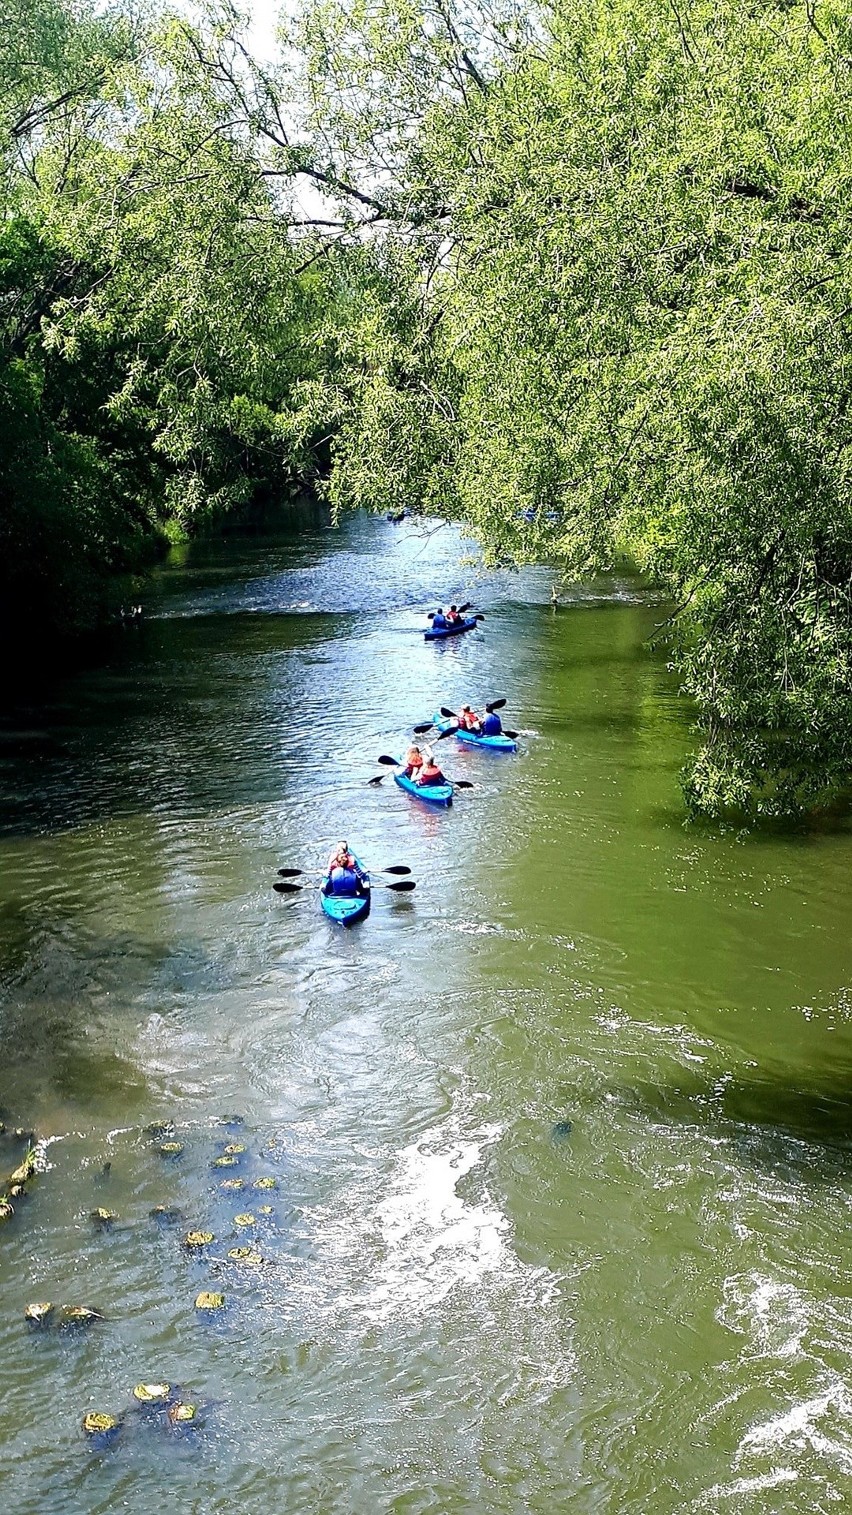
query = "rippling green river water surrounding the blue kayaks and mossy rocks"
xmin=0 ymin=520 xmax=852 ymax=1515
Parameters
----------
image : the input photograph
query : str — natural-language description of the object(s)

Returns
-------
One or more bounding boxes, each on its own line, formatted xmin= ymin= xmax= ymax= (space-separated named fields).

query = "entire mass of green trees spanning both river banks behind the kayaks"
xmin=0 ymin=0 xmax=852 ymax=814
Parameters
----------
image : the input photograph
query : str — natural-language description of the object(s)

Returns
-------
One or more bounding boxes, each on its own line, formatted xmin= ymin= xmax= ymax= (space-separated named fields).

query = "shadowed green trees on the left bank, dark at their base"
xmin=0 ymin=0 xmax=338 ymax=630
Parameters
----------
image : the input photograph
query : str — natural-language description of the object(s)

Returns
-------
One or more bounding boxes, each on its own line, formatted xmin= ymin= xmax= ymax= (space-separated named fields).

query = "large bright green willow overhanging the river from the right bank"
xmin=285 ymin=0 xmax=852 ymax=814
